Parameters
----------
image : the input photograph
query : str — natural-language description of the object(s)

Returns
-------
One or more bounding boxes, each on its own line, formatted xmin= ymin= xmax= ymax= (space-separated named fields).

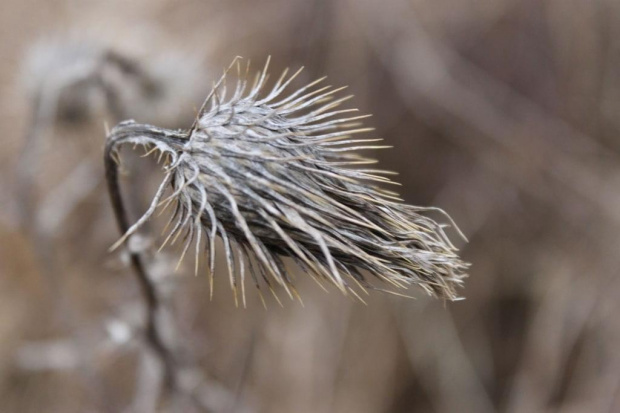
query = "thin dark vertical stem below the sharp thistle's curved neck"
xmin=104 ymin=141 xmax=177 ymax=389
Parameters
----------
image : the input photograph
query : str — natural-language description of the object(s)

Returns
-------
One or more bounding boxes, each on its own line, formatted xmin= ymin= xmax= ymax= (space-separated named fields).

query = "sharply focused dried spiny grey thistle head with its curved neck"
xmin=106 ymin=59 xmax=468 ymax=304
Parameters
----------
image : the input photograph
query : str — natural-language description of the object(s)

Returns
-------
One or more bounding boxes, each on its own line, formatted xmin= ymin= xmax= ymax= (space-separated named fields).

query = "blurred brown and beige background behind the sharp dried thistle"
xmin=0 ymin=0 xmax=620 ymax=413
